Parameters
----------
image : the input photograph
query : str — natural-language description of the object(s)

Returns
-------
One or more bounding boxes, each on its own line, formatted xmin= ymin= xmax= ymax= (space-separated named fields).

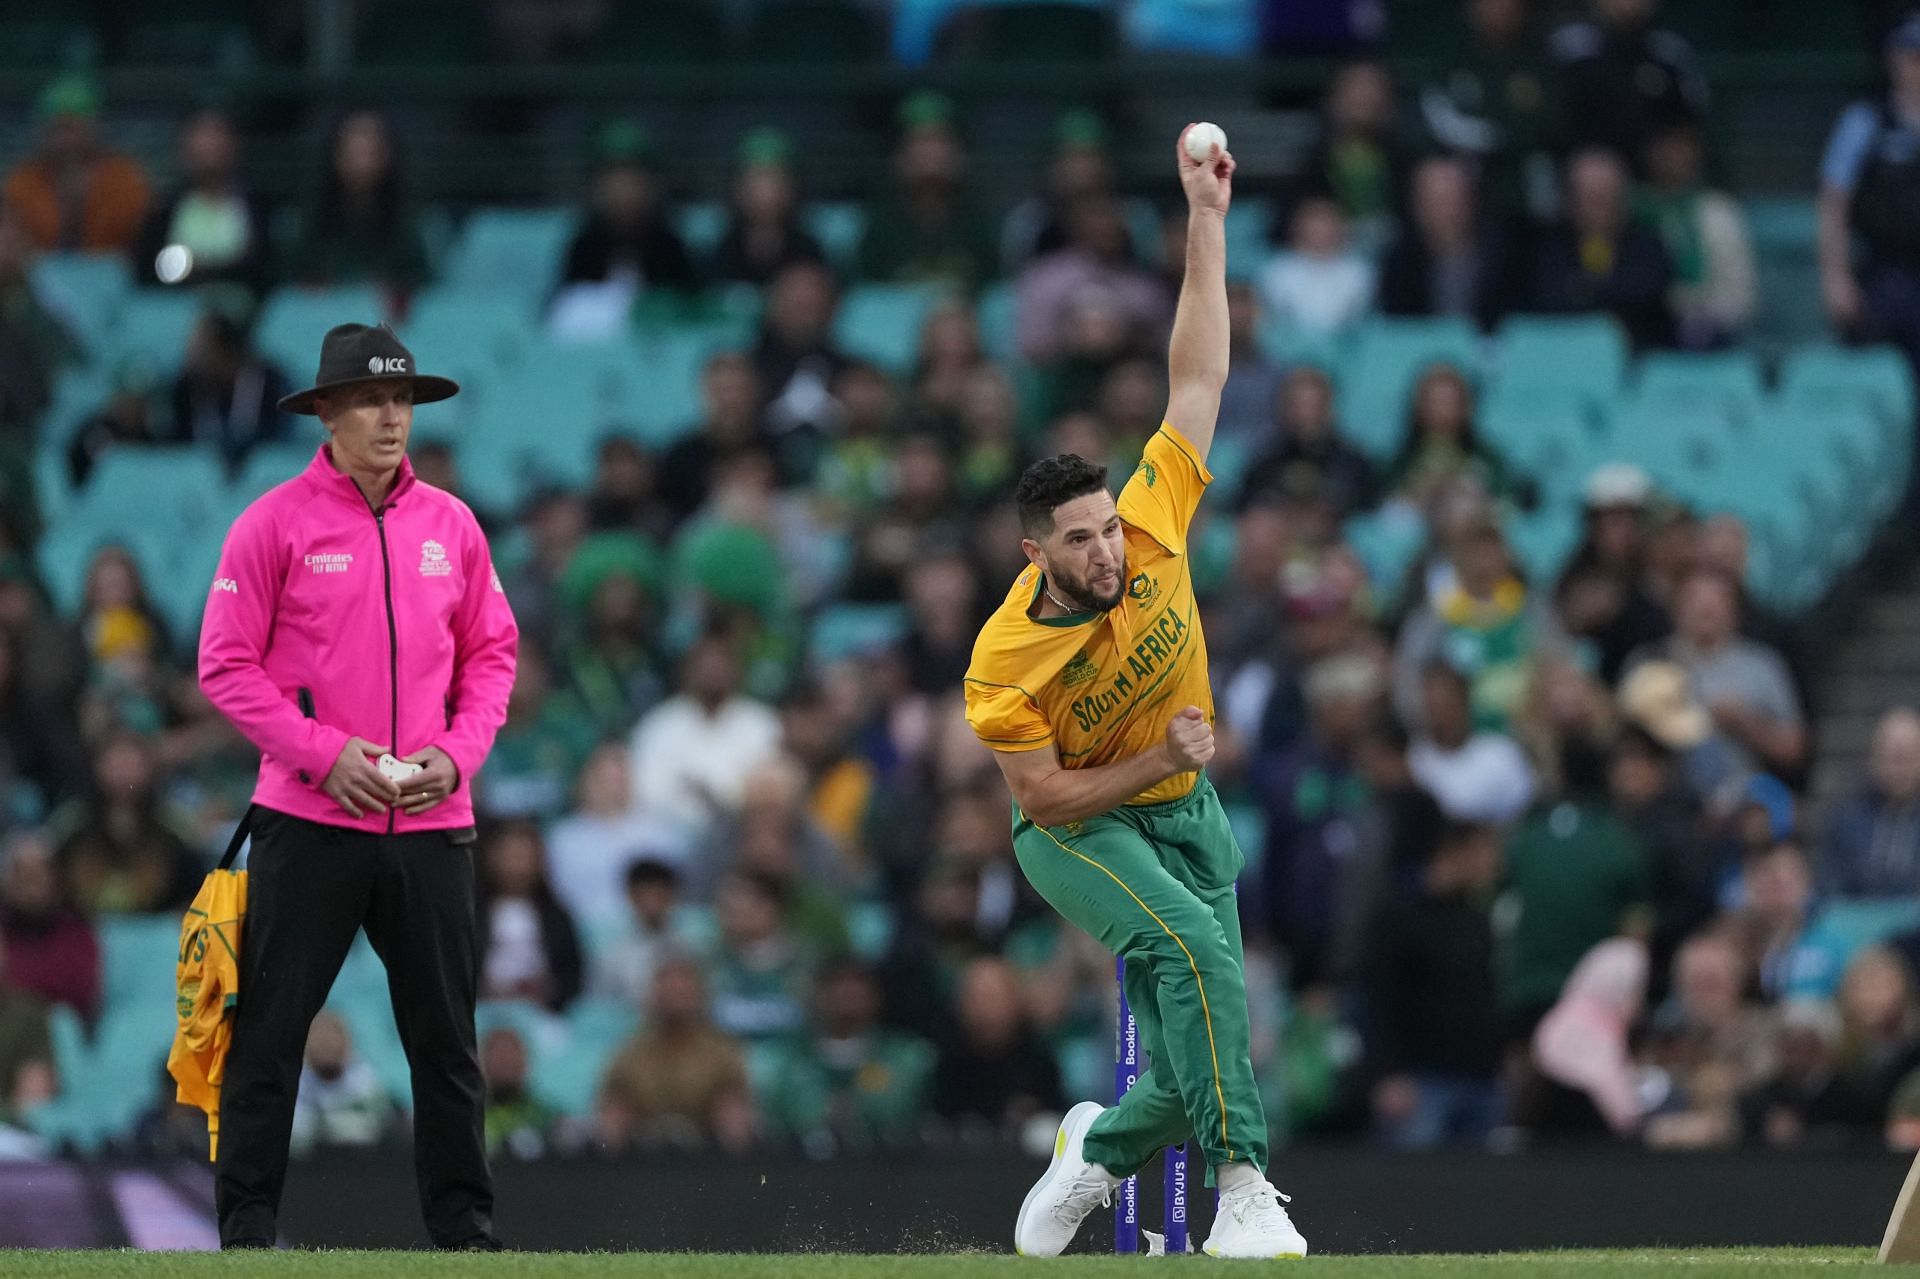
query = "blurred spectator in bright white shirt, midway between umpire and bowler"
xmin=632 ymin=634 xmax=780 ymax=830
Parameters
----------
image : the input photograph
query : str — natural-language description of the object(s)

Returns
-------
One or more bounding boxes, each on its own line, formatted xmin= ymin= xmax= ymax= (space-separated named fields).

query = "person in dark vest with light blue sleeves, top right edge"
xmin=1820 ymin=13 xmax=1920 ymax=363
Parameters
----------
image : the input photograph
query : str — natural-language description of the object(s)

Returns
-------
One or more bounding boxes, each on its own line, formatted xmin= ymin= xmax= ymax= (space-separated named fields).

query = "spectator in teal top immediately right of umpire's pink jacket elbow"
xmin=474 ymin=640 xmax=595 ymax=822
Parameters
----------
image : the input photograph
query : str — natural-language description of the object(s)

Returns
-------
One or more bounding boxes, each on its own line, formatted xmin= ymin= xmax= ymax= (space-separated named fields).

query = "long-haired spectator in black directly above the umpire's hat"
xmin=288 ymin=111 xmax=430 ymax=294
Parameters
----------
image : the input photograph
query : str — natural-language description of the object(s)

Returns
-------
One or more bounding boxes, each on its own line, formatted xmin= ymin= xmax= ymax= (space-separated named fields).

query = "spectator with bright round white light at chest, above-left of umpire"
xmin=132 ymin=108 xmax=270 ymax=295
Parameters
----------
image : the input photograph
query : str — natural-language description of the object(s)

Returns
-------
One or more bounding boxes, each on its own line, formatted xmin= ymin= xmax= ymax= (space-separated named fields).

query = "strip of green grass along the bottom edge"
xmin=0 ymin=1248 xmax=1874 ymax=1279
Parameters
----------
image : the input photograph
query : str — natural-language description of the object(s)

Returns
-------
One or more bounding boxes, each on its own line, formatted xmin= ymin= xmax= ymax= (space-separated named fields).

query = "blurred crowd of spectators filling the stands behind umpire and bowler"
xmin=0 ymin=0 xmax=1920 ymax=1156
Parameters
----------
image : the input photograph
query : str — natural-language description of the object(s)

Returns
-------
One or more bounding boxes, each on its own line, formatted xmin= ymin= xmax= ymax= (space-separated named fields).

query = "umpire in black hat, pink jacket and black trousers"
xmin=200 ymin=325 xmax=518 ymax=1250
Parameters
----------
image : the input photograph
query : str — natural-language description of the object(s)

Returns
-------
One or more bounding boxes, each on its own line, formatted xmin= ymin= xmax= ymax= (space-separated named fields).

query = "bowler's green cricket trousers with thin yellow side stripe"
xmin=1014 ymin=774 xmax=1267 ymax=1181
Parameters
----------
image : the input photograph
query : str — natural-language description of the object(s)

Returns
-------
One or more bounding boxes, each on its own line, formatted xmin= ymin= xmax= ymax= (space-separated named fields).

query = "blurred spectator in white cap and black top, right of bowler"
xmin=1555 ymin=463 xmax=1672 ymax=684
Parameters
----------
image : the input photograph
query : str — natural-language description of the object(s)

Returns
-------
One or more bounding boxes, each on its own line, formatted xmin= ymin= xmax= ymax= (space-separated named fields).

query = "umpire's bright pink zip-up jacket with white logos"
xmin=200 ymin=444 xmax=520 ymax=832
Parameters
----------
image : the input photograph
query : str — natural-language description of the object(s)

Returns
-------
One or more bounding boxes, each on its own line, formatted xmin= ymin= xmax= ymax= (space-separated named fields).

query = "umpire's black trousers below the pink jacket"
xmin=215 ymin=807 xmax=493 ymax=1246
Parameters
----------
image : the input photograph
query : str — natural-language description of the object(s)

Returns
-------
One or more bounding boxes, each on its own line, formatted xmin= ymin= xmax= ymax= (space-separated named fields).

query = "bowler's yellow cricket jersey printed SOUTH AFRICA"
xmin=966 ymin=424 xmax=1213 ymax=805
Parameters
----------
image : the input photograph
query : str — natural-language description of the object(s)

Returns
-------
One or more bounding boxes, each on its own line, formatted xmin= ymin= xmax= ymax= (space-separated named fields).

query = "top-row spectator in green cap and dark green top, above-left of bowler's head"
xmin=858 ymin=90 xmax=1000 ymax=292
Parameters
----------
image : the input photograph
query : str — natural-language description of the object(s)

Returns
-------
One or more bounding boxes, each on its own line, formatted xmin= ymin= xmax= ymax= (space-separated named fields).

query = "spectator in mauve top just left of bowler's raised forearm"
xmin=1014 ymin=196 xmax=1173 ymax=365
